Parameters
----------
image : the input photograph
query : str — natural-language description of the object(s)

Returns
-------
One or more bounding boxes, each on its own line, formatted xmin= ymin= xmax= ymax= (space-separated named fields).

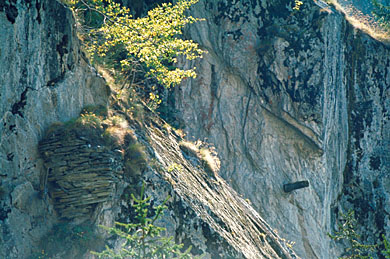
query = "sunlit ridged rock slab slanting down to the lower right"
xmin=136 ymin=117 xmax=296 ymax=258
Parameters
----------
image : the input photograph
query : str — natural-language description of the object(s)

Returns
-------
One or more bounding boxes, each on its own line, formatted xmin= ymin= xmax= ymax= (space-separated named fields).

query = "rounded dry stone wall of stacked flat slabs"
xmin=39 ymin=129 xmax=123 ymax=220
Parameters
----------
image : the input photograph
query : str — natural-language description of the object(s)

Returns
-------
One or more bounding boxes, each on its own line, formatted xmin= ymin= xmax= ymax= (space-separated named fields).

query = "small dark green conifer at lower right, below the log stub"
xmin=328 ymin=210 xmax=376 ymax=259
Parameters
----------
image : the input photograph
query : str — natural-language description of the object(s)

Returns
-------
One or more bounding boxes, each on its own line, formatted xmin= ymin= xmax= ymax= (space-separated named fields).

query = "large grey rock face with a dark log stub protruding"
xmin=174 ymin=0 xmax=390 ymax=258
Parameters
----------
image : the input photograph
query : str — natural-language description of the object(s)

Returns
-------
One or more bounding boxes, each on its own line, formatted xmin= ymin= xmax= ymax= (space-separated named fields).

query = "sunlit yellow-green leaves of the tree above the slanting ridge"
xmin=75 ymin=0 xmax=204 ymax=88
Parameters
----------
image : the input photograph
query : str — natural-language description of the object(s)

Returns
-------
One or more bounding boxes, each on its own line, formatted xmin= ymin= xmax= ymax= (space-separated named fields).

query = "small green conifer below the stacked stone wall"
xmin=93 ymin=185 xmax=192 ymax=259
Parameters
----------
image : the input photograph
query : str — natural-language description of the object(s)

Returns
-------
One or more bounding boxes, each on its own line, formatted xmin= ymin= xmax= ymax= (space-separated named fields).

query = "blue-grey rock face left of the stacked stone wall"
xmin=0 ymin=0 xmax=108 ymax=258
